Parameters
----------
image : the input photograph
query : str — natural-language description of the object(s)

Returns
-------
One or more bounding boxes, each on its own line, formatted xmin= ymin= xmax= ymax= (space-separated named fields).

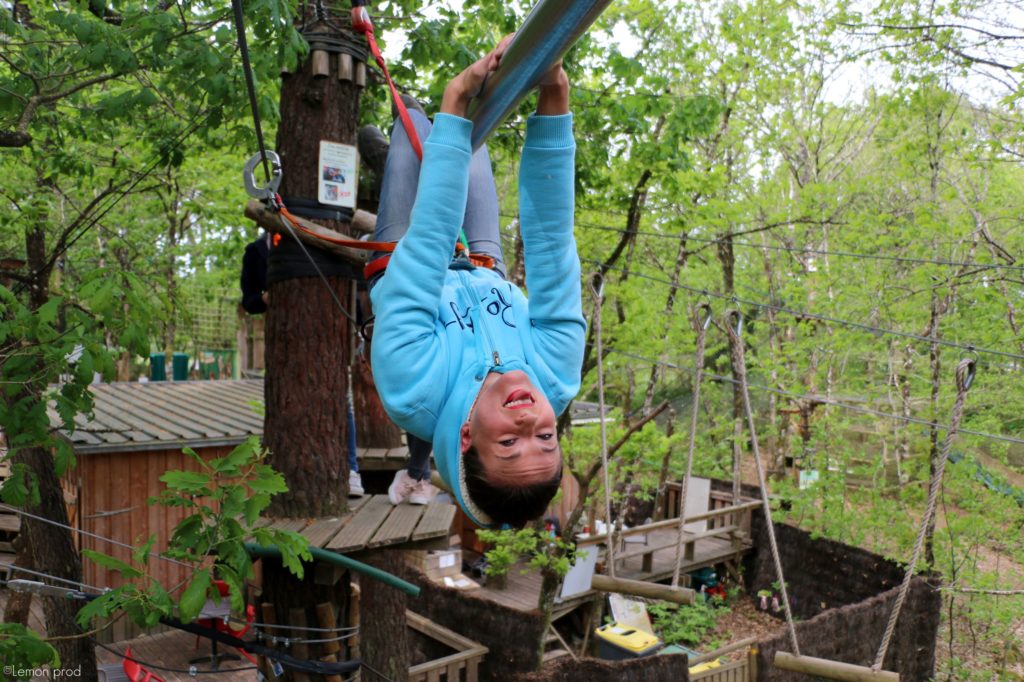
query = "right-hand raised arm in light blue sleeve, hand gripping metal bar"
xmin=519 ymin=71 xmax=586 ymax=405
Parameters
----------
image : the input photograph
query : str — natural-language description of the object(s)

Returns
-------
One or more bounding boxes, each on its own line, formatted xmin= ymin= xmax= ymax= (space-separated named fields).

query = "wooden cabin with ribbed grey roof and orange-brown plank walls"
xmin=51 ymin=380 xmax=263 ymax=587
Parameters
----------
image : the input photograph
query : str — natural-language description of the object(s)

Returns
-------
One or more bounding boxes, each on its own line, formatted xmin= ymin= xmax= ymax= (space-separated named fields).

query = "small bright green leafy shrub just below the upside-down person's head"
xmin=476 ymin=527 xmax=577 ymax=578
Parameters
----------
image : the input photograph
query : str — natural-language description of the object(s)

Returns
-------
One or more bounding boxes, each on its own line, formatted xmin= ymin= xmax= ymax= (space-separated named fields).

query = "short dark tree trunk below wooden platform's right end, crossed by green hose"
xmin=359 ymin=550 xmax=410 ymax=680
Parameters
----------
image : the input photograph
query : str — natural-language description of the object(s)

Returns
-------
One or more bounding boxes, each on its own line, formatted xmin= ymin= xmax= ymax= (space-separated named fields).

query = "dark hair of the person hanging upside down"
xmin=462 ymin=446 xmax=562 ymax=528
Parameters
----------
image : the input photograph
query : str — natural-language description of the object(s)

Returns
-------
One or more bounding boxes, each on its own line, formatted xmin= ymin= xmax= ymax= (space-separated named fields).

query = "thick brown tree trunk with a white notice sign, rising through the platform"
xmin=257 ymin=18 xmax=370 ymax=680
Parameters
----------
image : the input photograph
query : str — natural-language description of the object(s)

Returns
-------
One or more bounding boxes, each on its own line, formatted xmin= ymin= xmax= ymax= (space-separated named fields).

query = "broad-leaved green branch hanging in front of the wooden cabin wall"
xmin=78 ymin=437 xmax=311 ymax=627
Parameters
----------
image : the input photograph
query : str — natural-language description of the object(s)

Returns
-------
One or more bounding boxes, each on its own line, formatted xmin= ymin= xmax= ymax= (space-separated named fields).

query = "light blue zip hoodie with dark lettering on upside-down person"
xmin=371 ymin=114 xmax=586 ymax=526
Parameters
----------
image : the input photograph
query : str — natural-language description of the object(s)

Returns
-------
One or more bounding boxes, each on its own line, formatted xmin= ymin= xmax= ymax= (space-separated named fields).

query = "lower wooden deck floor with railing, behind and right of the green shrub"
xmin=472 ymin=528 xmax=751 ymax=611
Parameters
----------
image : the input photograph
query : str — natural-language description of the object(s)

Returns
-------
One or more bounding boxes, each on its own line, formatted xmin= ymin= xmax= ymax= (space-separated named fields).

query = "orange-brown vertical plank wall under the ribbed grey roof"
xmin=70 ymin=446 xmax=231 ymax=597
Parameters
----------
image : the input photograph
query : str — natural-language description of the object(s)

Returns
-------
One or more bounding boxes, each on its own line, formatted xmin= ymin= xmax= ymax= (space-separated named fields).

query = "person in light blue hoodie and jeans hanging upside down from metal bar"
xmin=371 ymin=39 xmax=586 ymax=527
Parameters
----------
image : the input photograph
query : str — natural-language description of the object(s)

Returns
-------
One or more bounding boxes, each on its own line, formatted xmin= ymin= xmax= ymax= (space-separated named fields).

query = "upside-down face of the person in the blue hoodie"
xmin=461 ymin=370 xmax=562 ymax=486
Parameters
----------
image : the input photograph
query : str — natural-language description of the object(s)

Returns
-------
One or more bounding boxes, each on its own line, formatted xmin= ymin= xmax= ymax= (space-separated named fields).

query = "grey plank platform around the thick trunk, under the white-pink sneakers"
xmin=258 ymin=495 xmax=456 ymax=554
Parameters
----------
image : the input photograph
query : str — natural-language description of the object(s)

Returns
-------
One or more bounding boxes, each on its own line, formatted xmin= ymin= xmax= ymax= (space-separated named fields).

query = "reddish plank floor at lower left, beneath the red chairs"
xmin=96 ymin=630 xmax=256 ymax=682
